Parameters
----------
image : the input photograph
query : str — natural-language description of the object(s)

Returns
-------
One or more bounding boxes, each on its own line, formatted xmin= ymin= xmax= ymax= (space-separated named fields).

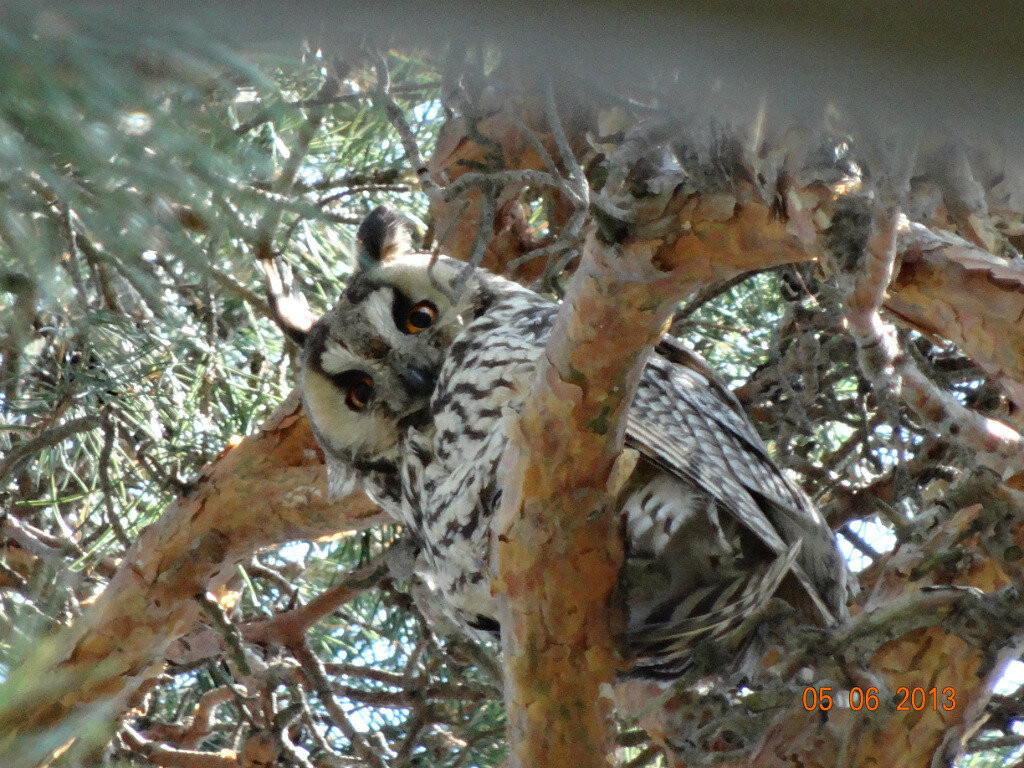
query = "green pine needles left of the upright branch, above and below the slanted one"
xmin=0 ymin=9 xmax=483 ymax=764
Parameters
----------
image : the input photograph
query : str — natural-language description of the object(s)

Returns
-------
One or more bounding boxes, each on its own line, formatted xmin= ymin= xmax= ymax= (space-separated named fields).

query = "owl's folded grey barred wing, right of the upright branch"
xmin=626 ymin=342 xmax=846 ymax=624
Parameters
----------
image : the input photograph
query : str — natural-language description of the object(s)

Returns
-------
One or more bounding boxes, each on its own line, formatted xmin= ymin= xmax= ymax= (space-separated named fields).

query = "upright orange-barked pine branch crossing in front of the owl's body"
xmin=495 ymin=225 xmax=685 ymax=767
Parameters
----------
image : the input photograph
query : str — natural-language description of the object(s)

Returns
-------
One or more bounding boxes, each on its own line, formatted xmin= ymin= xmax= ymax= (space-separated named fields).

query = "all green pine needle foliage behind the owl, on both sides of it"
xmin=0 ymin=7 xmax=1019 ymax=767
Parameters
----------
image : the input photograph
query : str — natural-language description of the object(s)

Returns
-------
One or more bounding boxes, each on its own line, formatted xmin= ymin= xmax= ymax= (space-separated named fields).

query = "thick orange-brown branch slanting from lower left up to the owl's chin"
xmin=0 ymin=395 xmax=379 ymax=762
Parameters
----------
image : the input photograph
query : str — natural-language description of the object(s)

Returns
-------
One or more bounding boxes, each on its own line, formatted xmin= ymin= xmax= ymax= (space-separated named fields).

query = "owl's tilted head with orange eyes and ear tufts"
xmin=270 ymin=207 xmax=497 ymax=509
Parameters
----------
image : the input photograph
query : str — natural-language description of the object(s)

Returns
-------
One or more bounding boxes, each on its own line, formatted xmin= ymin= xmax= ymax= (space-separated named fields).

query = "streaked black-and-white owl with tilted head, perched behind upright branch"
xmin=271 ymin=208 xmax=847 ymax=679
